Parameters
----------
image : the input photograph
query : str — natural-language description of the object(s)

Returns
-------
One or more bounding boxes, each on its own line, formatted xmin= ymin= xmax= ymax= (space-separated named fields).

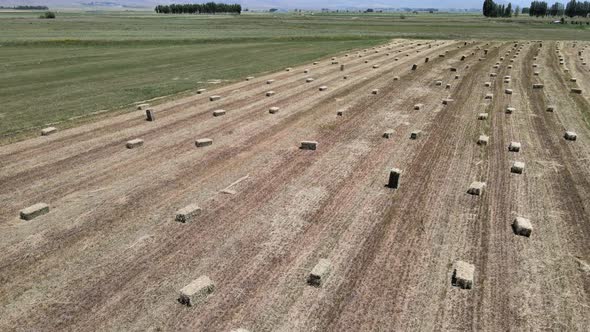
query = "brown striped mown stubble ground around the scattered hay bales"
xmin=0 ymin=40 xmax=590 ymax=331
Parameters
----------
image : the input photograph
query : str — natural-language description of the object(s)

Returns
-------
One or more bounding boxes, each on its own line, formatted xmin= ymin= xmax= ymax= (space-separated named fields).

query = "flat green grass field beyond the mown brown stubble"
xmin=0 ymin=11 xmax=590 ymax=141
